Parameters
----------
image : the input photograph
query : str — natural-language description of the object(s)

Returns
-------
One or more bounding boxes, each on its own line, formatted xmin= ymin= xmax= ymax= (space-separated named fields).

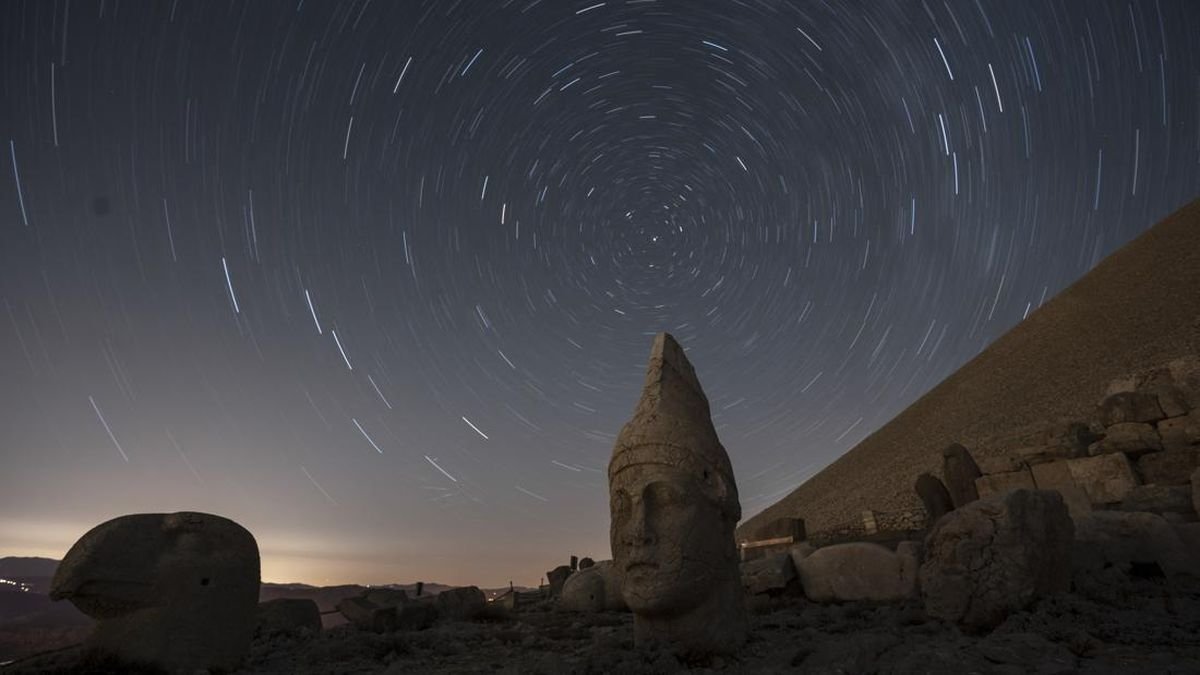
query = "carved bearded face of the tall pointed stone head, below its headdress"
xmin=610 ymin=464 xmax=733 ymax=616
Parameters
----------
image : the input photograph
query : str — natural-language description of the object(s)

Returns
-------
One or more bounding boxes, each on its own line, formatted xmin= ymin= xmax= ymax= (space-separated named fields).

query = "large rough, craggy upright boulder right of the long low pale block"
xmin=920 ymin=490 xmax=1074 ymax=629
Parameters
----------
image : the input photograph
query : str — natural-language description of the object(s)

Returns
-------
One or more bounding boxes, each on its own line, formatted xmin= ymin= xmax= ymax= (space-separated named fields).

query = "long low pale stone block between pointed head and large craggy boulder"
xmin=797 ymin=538 xmax=916 ymax=603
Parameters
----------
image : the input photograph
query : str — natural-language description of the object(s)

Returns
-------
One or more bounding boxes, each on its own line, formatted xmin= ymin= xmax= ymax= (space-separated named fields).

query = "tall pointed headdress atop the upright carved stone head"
xmin=608 ymin=333 xmax=742 ymax=521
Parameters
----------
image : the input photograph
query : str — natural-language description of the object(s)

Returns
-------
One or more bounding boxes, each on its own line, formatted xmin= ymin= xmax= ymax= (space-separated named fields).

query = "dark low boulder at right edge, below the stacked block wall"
xmin=1075 ymin=510 xmax=1200 ymax=578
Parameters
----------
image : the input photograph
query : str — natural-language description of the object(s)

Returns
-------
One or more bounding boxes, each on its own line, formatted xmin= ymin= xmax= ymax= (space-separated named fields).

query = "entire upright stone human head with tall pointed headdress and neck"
xmin=608 ymin=333 xmax=746 ymax=653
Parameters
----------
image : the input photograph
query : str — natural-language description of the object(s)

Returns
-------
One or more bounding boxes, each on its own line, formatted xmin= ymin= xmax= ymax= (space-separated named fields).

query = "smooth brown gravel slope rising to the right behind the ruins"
xmin=738 ymin=199 xmax=1200 ymax=539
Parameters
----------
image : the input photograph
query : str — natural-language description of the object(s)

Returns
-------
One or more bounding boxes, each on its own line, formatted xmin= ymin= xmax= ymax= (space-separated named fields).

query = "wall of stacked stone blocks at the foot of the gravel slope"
xmin=787 ymin=356 xmax=1200 ymax=545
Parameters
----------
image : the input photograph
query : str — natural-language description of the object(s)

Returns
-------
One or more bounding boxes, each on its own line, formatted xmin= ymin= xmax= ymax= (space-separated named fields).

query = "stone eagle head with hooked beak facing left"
xmin=50 ymin=512 xmax=259 ymax=671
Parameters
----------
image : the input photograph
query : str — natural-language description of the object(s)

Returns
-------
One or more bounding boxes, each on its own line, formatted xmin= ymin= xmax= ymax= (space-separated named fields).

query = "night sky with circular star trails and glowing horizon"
xmin=0 ymin=0 xmax=1200 ymax=586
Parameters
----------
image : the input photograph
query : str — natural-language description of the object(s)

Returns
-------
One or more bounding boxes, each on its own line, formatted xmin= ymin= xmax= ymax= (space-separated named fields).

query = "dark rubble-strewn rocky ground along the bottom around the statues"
xmin=9 ymin=575 xmax=1200 ymax=675
